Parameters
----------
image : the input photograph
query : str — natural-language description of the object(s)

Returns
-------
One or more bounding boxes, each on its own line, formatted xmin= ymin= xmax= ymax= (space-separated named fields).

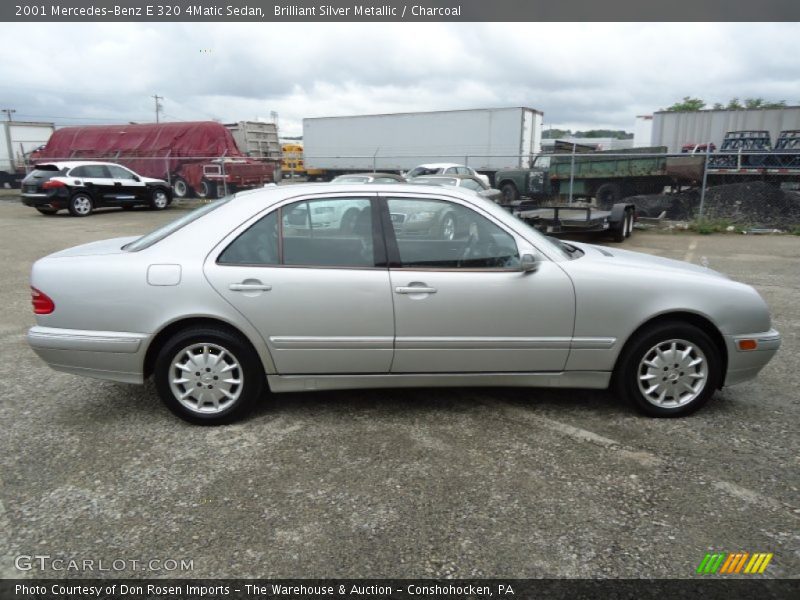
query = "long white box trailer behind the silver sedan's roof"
xmin=303 ymin=107 xmax=543 ymax=175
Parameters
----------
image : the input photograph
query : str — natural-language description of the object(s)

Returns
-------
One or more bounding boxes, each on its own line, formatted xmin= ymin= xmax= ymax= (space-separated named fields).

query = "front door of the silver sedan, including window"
xmin=386 ymin=195 xmax=575 ymax=373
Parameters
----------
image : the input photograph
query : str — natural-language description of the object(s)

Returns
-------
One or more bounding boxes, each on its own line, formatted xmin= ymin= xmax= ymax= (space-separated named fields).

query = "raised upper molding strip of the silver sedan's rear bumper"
xmin=28 ymin=325 xmax=148 ymax=354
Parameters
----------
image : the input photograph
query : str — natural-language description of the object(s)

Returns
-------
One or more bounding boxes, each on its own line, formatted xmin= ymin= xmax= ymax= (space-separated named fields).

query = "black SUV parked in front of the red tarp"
xmin=22 ymin=161 xmax=172 ymax=217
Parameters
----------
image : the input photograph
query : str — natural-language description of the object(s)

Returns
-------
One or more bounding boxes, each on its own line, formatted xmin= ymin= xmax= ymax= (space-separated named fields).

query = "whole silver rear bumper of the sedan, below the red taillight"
xmin=28 ymin=326 xmax=150 ymax=383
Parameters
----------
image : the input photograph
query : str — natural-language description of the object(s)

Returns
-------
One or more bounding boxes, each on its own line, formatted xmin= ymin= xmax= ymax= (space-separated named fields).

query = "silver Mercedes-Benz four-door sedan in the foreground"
xmin=28 ymin=184 xmax=780 ymax=424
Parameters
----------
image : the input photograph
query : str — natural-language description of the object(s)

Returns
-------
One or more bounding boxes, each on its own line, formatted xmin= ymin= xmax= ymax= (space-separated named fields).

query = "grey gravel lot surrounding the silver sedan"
xmin=0 ymin=196 xmax=800 ymax=577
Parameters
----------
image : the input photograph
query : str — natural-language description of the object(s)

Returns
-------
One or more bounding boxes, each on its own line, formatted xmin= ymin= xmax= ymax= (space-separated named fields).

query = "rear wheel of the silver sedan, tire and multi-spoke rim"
xmin=154 ymin=327 xmax=264 ymax=425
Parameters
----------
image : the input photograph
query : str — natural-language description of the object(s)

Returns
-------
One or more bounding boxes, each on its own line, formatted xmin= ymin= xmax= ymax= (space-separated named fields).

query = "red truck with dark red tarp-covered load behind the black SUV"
xmin=36 ymin=121 xmax=280 ymax=198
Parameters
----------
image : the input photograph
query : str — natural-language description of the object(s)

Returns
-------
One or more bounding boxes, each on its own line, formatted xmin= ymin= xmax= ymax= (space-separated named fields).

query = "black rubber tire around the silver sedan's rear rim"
xmin=153 ymin=327 xmax=265 ymax=425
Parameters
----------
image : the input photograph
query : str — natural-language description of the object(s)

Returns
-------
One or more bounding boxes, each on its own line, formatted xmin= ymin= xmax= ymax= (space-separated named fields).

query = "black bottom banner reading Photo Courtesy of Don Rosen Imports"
xmin=0 ymin=576 xmax=800 ymax=600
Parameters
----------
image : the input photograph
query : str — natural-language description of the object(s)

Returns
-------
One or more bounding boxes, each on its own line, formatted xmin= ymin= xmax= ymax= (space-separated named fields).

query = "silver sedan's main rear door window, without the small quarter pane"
xmin=281 ymin=198 xmax=375 ymax=267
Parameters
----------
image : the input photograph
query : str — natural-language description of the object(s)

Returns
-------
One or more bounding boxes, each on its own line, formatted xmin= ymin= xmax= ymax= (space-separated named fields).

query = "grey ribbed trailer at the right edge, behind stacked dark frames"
xmin=648 ymin=106 xmax=800 ymax=152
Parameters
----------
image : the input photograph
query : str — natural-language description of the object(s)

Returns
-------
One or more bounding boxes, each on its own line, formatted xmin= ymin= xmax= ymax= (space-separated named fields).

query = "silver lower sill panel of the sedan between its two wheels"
xmin=267 ymin=371 xmax=611 ymax=392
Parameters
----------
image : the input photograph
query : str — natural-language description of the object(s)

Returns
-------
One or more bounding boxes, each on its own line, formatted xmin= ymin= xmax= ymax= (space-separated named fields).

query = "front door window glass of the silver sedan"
xmin=387 ymin=198 xmax=519 ymax=269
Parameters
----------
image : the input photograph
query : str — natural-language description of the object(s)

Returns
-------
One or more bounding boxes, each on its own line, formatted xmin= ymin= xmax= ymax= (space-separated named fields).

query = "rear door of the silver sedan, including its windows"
xmin=205 ymin=195 xmax=394 ymax=375
